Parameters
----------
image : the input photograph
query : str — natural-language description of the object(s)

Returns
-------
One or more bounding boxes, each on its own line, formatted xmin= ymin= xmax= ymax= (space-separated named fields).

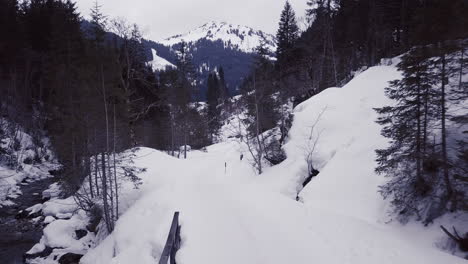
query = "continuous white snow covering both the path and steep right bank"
xmin=81 ymin=60 xmax=466 ymax=264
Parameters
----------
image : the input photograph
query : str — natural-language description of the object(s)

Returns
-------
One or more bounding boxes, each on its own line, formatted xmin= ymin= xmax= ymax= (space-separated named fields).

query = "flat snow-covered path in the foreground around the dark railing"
xmin=84 ymin=143 xmax=466 ymax=264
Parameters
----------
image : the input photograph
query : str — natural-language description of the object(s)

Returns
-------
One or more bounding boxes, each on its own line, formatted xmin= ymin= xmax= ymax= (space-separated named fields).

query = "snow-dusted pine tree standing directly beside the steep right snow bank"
xmin=376 ymin=48 xmax=436 ymax=221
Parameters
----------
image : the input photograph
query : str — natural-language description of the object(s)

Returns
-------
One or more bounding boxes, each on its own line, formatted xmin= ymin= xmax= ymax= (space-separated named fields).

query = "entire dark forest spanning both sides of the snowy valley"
xmin=0 ymin=0 xmax=468 ymax=237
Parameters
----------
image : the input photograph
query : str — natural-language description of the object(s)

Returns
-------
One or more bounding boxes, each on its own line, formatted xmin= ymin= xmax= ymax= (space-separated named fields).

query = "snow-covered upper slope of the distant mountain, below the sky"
xmin=159 ymin=22 xmax=276 ymax=52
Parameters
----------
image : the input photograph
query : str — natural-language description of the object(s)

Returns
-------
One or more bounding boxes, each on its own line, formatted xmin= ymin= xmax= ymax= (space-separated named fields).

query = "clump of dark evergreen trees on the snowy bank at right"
xmin=376 ymin=43 xmax=466 ymax=222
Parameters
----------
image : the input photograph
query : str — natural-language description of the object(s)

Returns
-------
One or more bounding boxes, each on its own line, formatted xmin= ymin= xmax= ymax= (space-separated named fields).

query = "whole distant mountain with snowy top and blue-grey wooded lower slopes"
xmin=143 ymin=22 xmax=276 ymax=99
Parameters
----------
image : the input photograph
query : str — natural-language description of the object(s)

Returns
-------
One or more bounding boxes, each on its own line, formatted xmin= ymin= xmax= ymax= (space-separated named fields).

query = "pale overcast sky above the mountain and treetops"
xmin=76 ymin=0 xmax=307 ymax=40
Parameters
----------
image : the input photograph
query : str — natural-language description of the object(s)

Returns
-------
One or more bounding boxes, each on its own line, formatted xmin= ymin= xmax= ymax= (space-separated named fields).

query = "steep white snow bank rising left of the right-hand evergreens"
xmin=292 ymin=63 xmax=400 ymax=222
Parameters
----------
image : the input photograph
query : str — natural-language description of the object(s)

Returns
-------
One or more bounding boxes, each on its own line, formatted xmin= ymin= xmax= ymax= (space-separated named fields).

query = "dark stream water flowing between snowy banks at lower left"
xmin=0 ymin=178 xmax=54 ymax=264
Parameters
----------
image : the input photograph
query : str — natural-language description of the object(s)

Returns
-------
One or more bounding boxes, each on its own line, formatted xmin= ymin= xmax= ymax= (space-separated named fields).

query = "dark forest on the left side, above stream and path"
xmin=0 ymin=0 xmax=210 ymax=230
